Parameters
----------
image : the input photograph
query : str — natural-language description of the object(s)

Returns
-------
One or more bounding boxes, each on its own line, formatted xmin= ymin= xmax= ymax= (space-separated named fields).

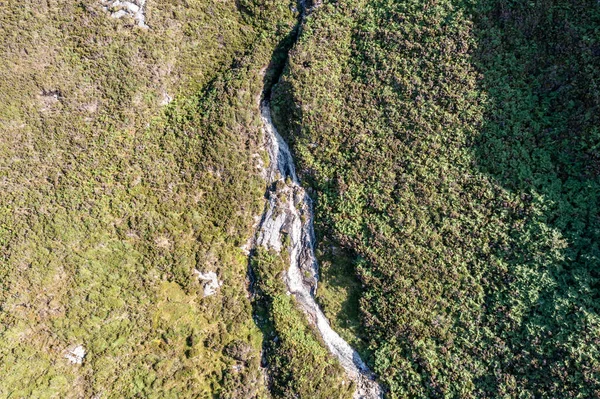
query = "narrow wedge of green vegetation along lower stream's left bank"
xmin=252 ymin=248 xmax=354 ymax=399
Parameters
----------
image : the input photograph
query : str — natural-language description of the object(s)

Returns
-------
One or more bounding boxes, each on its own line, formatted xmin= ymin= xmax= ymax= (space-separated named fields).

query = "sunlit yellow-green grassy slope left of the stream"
xmin=0 ymin=1 xmax=293 ymax=398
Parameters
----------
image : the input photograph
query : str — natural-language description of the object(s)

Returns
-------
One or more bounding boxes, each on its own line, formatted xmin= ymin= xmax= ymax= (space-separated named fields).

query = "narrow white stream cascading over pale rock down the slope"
xmin=256 ymin=100 xmax=382 ymax=399
